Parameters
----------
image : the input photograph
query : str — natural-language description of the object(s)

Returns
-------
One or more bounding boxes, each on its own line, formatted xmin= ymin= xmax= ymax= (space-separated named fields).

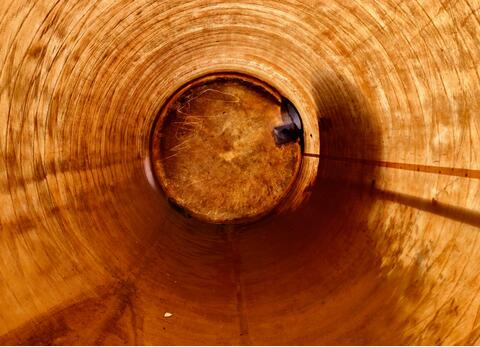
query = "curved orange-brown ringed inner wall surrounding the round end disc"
xmin=0 ymin=0 xmax=480 ymax=344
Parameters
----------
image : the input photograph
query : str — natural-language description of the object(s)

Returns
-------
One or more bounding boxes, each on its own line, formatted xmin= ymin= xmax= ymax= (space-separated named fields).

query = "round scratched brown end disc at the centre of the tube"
xmin=151 ymin=73 xmax=302 ymax=223
